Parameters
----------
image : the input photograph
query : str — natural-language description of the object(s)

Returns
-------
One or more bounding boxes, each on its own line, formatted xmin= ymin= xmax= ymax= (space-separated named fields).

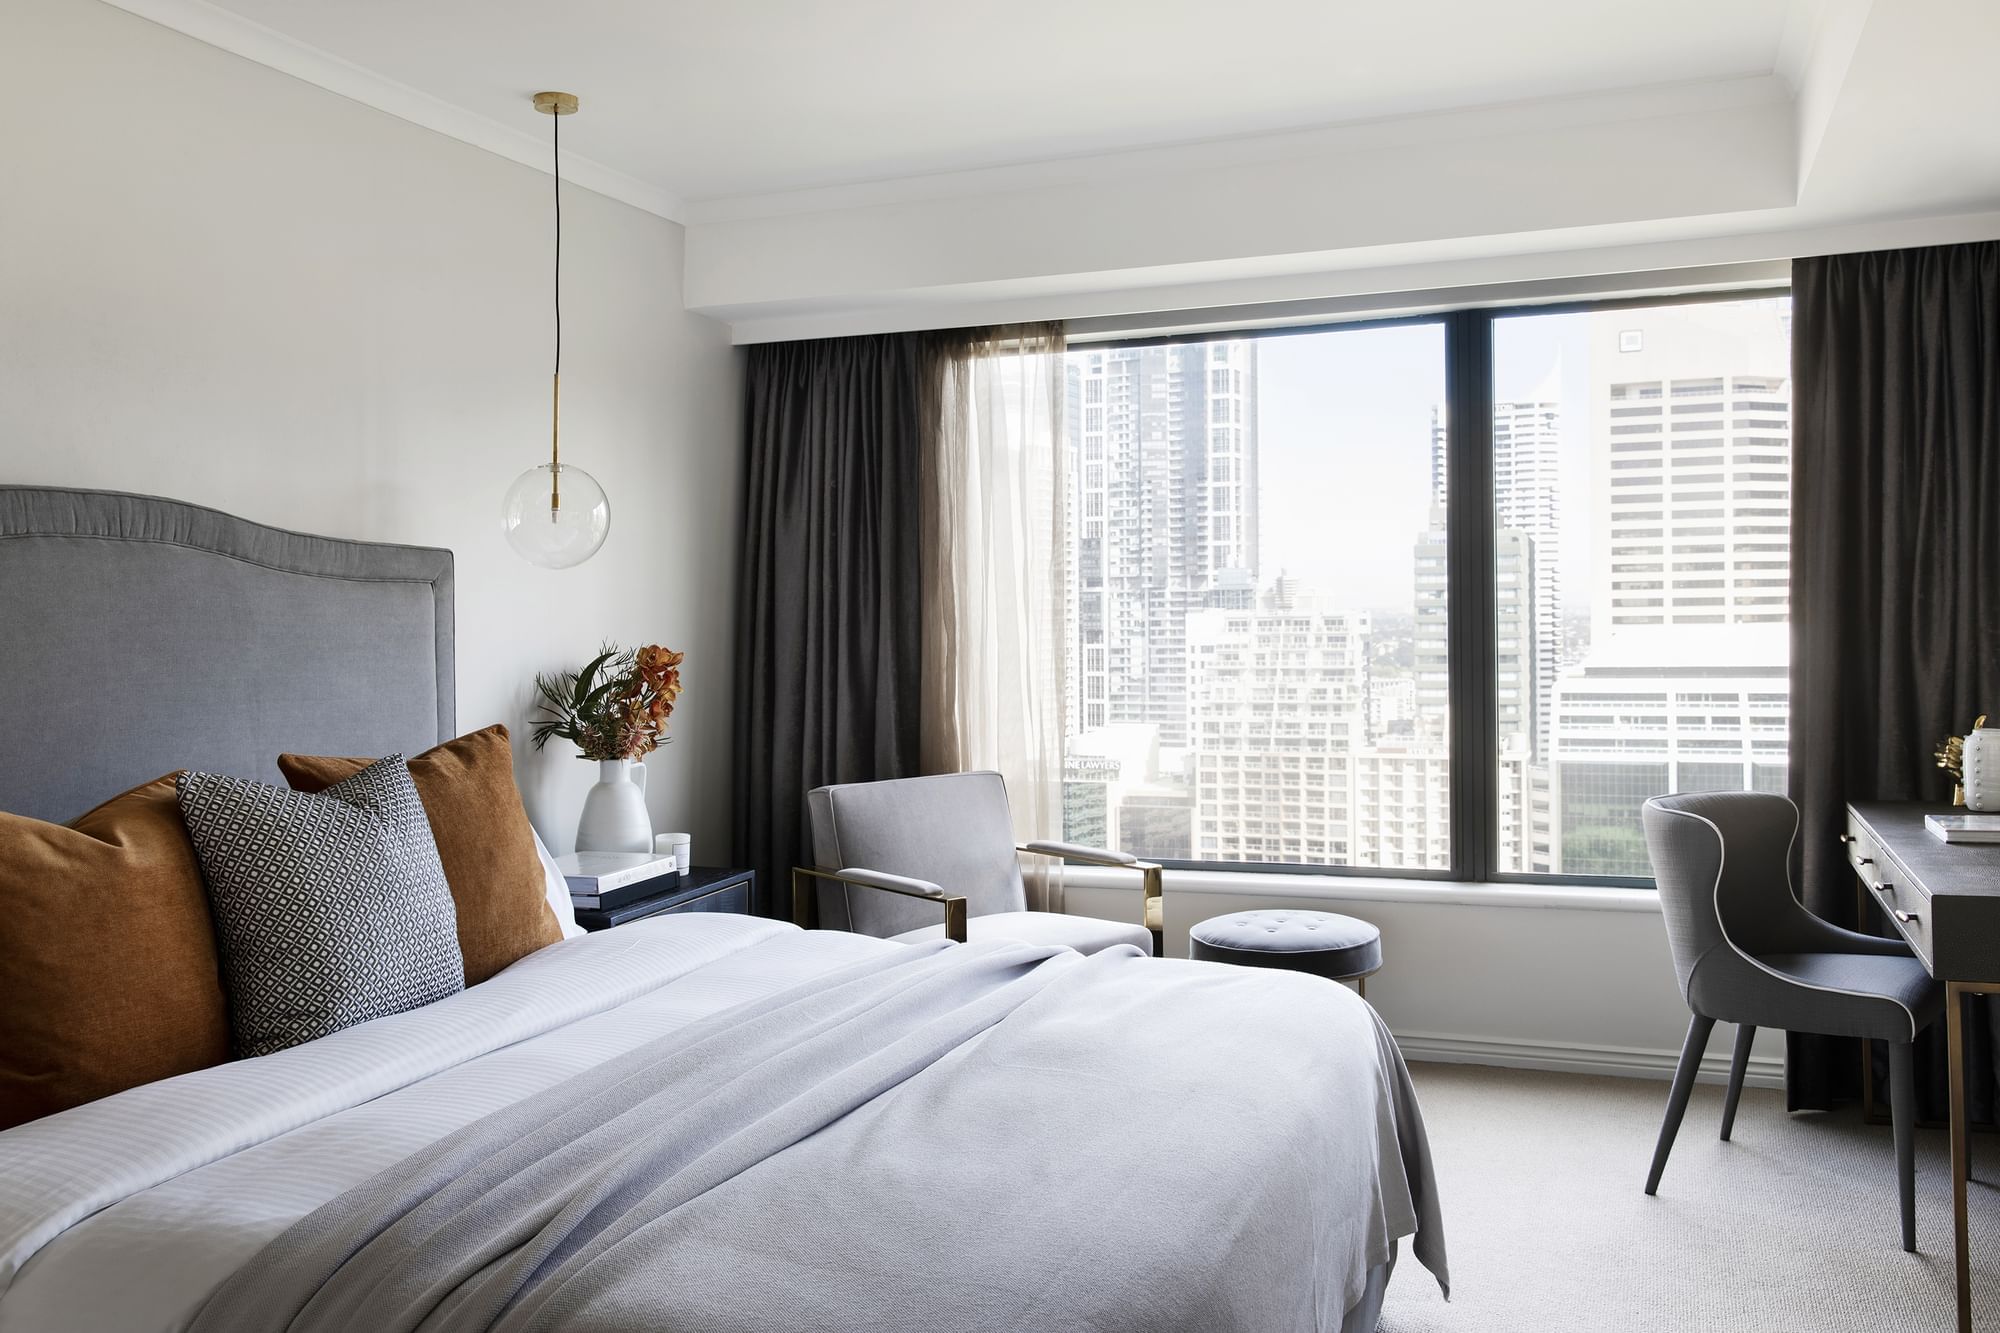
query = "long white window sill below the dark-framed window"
xmin=1062 ymin=865 xmax=1660 ymax=915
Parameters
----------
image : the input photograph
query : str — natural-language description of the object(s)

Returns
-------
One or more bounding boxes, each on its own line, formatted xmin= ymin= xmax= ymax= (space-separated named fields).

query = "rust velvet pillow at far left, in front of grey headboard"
xmin=0 ymin=775 xmax=230 ymax=1129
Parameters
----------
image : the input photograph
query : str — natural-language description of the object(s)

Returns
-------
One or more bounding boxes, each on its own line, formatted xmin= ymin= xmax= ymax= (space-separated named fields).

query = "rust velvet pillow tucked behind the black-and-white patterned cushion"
xmin=278 ymin=725 xmax=562 ymax=987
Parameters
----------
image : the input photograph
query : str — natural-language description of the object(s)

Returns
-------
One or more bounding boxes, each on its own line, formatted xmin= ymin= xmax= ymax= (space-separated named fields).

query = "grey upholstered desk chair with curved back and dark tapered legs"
xmin=1642 ymin=791 xmax=1944 ymax=1251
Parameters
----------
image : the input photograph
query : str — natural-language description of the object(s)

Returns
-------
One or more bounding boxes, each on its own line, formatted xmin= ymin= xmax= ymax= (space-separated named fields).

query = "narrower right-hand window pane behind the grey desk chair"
xmin=1494 ymin=298 xmax=1790 ymax=877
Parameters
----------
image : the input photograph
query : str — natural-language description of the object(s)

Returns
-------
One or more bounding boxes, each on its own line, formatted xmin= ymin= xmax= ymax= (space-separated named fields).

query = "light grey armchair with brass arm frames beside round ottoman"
xmin=792 ymin=773 xmax=1162 ymax=955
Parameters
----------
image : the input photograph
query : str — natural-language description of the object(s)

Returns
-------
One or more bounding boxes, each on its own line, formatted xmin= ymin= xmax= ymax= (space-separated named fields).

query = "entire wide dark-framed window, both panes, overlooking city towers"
xmin=1064 ymin=294 xmax=1792 ymax=881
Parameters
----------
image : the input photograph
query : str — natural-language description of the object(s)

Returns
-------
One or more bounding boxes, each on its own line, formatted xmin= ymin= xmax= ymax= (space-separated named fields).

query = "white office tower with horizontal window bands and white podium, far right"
xmin=1552 ymin=302 xmax=1792 ymax=875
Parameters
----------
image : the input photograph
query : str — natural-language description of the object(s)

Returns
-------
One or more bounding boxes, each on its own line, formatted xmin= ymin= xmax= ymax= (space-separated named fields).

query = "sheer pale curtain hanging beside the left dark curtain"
xmin=924 ymin=324 xmax=1066 ymax=868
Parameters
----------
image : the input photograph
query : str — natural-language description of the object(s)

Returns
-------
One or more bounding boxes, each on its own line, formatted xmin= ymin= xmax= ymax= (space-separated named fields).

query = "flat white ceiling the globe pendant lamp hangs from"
xmin=117 ymin=0 xmax=1810 ymax=200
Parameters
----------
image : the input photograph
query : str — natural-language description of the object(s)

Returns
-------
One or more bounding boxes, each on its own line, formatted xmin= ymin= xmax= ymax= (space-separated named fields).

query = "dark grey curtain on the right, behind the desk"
xmin=1788 ymin=242 xmax=2000 ymax=1121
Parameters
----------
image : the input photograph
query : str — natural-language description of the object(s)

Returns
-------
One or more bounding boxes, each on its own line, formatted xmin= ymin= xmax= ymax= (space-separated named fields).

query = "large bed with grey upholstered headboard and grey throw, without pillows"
xmin=0 ymin=486 xmax=1446 ymax=1333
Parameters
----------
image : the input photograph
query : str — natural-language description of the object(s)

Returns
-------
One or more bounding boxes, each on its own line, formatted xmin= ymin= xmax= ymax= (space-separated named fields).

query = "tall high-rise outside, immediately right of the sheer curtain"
xmin=1068 ymin=342 xmax=1258 ymax=747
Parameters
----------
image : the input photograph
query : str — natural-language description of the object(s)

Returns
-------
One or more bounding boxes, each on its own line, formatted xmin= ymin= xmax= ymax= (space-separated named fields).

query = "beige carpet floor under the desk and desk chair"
xmin=1382 ymin=1065 xmax=2000 ymax=1333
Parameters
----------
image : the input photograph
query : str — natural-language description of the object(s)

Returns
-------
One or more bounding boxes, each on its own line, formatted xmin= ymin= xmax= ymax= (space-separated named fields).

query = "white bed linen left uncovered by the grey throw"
xmin=0 ymin=913 xmax=900 ymax=1333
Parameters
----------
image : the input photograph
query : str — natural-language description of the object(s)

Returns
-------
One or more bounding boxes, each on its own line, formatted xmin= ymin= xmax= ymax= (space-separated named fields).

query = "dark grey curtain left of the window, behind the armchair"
xmin=734 ymin=334 xmax=942 ymax=917
